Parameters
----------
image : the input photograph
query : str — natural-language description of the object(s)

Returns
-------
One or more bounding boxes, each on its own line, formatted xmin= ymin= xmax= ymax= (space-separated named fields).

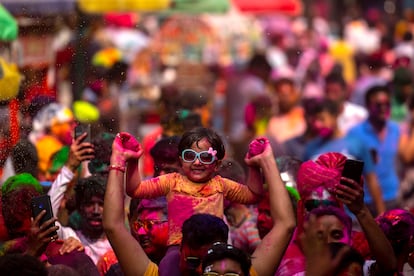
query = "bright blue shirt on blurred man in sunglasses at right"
xmin=348 ymin=120 xmax=401 ymax=203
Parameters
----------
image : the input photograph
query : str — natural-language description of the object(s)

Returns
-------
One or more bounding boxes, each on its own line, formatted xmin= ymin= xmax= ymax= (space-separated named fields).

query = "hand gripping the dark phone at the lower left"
xmin=27 ymin=210 xmax=59 ymax=257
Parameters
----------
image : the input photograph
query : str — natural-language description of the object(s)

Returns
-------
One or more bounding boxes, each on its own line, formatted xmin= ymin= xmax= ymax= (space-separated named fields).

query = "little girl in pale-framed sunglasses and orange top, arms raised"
xmin=110 ymin=128 xmax=270 ymax=270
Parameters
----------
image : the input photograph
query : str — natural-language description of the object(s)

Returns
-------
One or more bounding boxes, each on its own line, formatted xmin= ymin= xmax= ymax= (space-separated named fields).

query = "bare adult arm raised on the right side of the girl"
xmin=247 ymin=145 xmax=296 ymax=275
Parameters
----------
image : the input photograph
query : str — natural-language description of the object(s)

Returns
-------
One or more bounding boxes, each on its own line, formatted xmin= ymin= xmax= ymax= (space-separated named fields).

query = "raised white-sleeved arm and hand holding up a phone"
xmin=48 ymin=133 xmax=95 ymax=215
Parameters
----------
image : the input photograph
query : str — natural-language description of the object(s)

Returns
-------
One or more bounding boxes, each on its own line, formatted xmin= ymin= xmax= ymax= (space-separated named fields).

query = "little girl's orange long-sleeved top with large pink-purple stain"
xmin=134 ymin=173 xmax=260 ymax=245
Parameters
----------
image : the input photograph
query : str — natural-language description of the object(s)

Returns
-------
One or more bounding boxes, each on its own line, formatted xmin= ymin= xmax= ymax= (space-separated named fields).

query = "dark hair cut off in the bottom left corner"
xmin=0 ymin=254 xmax=48 ymax=276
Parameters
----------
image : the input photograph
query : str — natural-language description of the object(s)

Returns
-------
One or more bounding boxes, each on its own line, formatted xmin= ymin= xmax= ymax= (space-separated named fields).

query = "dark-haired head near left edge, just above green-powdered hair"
xmin=11 ymin=139 xmax=39 ymax=177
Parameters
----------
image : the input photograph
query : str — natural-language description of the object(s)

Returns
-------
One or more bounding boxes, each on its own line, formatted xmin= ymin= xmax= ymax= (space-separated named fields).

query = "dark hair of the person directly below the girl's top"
xmin=181 ymin=214 xmax=229 ymax=248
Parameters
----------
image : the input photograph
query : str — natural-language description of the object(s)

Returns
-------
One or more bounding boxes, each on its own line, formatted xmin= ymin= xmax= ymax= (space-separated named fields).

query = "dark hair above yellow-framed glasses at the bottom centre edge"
xmin=202 ymin=242 xmax=252 ymax=276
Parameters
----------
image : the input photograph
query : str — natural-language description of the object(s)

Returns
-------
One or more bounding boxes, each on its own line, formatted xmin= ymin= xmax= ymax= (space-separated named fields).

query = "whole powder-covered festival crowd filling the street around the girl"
xmin=0 ymin=2 xmax=414 ymax=276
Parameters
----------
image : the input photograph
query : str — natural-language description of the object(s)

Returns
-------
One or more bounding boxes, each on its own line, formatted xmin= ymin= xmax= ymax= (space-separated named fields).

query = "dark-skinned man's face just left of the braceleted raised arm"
xmin=80 ymin=196 xmax=104 ymax=234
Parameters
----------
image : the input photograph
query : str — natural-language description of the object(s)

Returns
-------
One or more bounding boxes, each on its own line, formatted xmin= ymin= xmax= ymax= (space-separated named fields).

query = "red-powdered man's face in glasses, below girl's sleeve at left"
xmin=130 ymin=209 xmax=168 ymax=255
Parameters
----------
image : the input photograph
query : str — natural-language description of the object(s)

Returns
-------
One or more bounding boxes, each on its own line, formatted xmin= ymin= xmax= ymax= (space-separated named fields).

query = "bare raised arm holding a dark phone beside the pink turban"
xmin=336 ymin=178 xmax=397 ymax=275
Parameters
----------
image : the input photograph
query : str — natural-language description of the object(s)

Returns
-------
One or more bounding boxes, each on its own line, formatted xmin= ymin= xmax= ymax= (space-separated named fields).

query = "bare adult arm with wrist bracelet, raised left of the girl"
xmin=103 ymin=138 xmax=150 ymax=276
